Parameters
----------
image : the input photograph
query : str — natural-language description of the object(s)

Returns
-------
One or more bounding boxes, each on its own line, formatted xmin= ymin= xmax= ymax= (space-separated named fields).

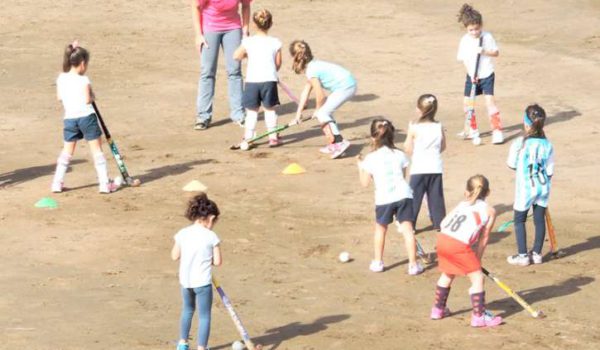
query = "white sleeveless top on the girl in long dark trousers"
xmin=408 ymin=123 xmax=442 ymax=175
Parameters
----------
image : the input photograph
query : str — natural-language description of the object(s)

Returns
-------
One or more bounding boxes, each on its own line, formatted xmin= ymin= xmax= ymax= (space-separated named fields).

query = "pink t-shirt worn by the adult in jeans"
xmin=198 ymin=0 xmax=252 ymax=33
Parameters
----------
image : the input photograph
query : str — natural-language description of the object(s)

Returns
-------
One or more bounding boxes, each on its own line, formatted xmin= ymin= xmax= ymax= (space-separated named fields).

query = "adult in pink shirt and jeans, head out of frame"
xmin=191 ymin=0 xmax=252 ymax=130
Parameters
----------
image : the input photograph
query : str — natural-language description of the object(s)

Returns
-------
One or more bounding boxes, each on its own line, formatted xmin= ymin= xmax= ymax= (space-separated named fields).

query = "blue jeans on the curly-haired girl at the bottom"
xmin=179 ymin=284 xmax=212 ymax=347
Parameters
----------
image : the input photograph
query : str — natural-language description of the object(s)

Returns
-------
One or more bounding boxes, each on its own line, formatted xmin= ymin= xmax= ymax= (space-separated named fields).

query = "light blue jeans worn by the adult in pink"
xmin=196 ymin=29 xmax=245 ymax=122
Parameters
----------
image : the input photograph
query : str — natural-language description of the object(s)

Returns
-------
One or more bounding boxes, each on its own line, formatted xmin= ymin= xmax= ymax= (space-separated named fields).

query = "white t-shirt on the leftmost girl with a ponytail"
xmin=56 ymin=72 xmax=94 ymax=119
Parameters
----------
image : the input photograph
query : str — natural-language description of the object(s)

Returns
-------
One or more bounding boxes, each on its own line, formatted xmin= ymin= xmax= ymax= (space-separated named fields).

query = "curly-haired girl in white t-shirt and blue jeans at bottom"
xmin=171 ymin=193 xmax=222 ymax=350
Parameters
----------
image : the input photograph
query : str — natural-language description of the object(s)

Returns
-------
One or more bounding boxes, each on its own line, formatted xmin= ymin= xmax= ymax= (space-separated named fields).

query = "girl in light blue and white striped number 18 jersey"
xmin=507 ymin=104 xmax=554 ymax=266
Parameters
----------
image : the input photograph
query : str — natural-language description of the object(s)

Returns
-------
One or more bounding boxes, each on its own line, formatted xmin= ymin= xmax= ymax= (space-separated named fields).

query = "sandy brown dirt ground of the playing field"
xmin=0 ymin=0 xmax=600 ymax=350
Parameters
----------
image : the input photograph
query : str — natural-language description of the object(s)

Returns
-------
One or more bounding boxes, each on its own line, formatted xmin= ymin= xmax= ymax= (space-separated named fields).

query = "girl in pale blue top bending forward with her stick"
xmin=290 ymin=40 xmax=356 ymax=159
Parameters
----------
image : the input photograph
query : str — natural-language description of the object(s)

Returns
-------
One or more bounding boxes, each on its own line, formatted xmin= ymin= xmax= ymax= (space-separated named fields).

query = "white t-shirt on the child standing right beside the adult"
xmin=242 ymin=35 xmax=281 ymax=83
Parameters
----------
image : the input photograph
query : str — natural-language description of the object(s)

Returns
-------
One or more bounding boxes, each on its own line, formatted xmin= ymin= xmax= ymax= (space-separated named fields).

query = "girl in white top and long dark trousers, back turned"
xmin=404 ymin=94 xmax=446 ymax=230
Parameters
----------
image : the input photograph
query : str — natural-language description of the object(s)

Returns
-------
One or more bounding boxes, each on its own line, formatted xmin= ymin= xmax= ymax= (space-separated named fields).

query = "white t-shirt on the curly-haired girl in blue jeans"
xmin=175 ymin=224 xmax=221 ymax=288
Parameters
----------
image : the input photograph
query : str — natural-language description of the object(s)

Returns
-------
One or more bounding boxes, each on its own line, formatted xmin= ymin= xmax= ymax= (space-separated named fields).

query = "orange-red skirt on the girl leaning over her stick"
xmin=436 ymin=233 xmax=481 ymax=276
